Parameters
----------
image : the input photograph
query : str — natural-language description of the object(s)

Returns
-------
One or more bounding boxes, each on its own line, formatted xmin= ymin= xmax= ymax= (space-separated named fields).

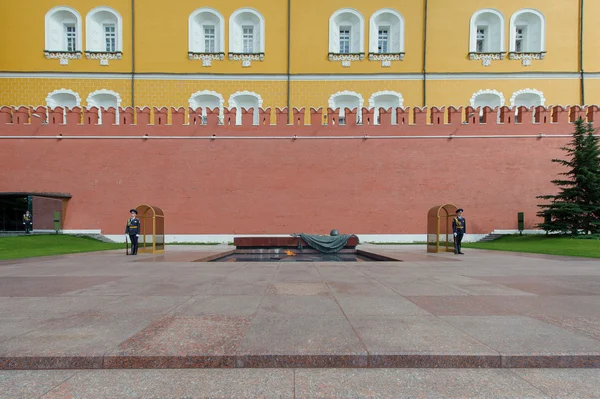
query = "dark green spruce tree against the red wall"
xmin=537 ymin=118 xmax=600 ymax=235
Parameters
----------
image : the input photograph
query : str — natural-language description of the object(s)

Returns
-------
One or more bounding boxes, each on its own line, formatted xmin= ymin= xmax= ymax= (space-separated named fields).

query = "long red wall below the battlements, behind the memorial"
xmin=0 ymin=107 xmax=584 ymax=238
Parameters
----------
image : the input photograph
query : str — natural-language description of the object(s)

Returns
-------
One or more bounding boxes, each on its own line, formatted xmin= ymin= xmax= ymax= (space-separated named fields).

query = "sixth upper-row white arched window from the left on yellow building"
xmin=369 ymin=8 xmax=404 ymax=67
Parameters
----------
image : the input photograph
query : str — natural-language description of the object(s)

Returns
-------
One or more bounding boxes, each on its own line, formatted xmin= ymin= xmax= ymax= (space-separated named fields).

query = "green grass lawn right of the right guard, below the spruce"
xmin=463 ymin=235 xmax=600 ymax=258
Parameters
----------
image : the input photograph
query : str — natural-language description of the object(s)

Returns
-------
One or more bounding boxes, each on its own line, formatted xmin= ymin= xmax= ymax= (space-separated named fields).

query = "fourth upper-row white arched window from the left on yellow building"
xmin=229 ymin=8 xmax=266 ymax=67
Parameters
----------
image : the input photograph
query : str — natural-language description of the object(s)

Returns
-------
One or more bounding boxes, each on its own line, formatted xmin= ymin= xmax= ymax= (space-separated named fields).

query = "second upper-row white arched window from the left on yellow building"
xmin=85 ymin=6 xmax=123 ymax=65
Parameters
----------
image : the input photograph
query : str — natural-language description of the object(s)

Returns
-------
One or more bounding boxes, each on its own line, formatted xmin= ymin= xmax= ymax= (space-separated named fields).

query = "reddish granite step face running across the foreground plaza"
xmin=0 ymin=351 xmax=600 ymax=370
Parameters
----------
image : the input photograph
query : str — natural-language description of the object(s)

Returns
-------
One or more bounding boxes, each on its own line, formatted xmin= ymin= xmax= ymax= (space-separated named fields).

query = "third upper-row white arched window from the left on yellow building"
xmin=188 ymin=7 xmax=225 ymax=67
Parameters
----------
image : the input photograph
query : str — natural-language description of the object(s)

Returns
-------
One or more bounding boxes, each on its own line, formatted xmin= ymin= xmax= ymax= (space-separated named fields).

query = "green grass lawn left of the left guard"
xmin=0 ymin=234 xmax=125 ymax=260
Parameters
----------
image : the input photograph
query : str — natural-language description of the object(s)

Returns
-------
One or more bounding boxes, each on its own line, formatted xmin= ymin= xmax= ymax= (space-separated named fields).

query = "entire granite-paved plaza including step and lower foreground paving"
xmin=0 ymin=245 xmax=600 ymax=399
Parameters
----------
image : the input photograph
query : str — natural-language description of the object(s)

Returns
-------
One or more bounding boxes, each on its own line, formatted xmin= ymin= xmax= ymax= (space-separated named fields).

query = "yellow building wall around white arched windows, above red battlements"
xmin=0 ymin=0 xmax=600 ymax=108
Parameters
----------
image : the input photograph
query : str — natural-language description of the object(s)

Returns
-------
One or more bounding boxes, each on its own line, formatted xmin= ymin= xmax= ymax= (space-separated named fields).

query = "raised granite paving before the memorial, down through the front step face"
xmin=0 ymin=246 xmax=600 ymax=369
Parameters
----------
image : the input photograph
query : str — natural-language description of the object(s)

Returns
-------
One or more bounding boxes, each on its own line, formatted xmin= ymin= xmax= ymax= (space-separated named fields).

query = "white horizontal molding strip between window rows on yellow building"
xmin=0 ymin=72 xmax=584 ymax=82
